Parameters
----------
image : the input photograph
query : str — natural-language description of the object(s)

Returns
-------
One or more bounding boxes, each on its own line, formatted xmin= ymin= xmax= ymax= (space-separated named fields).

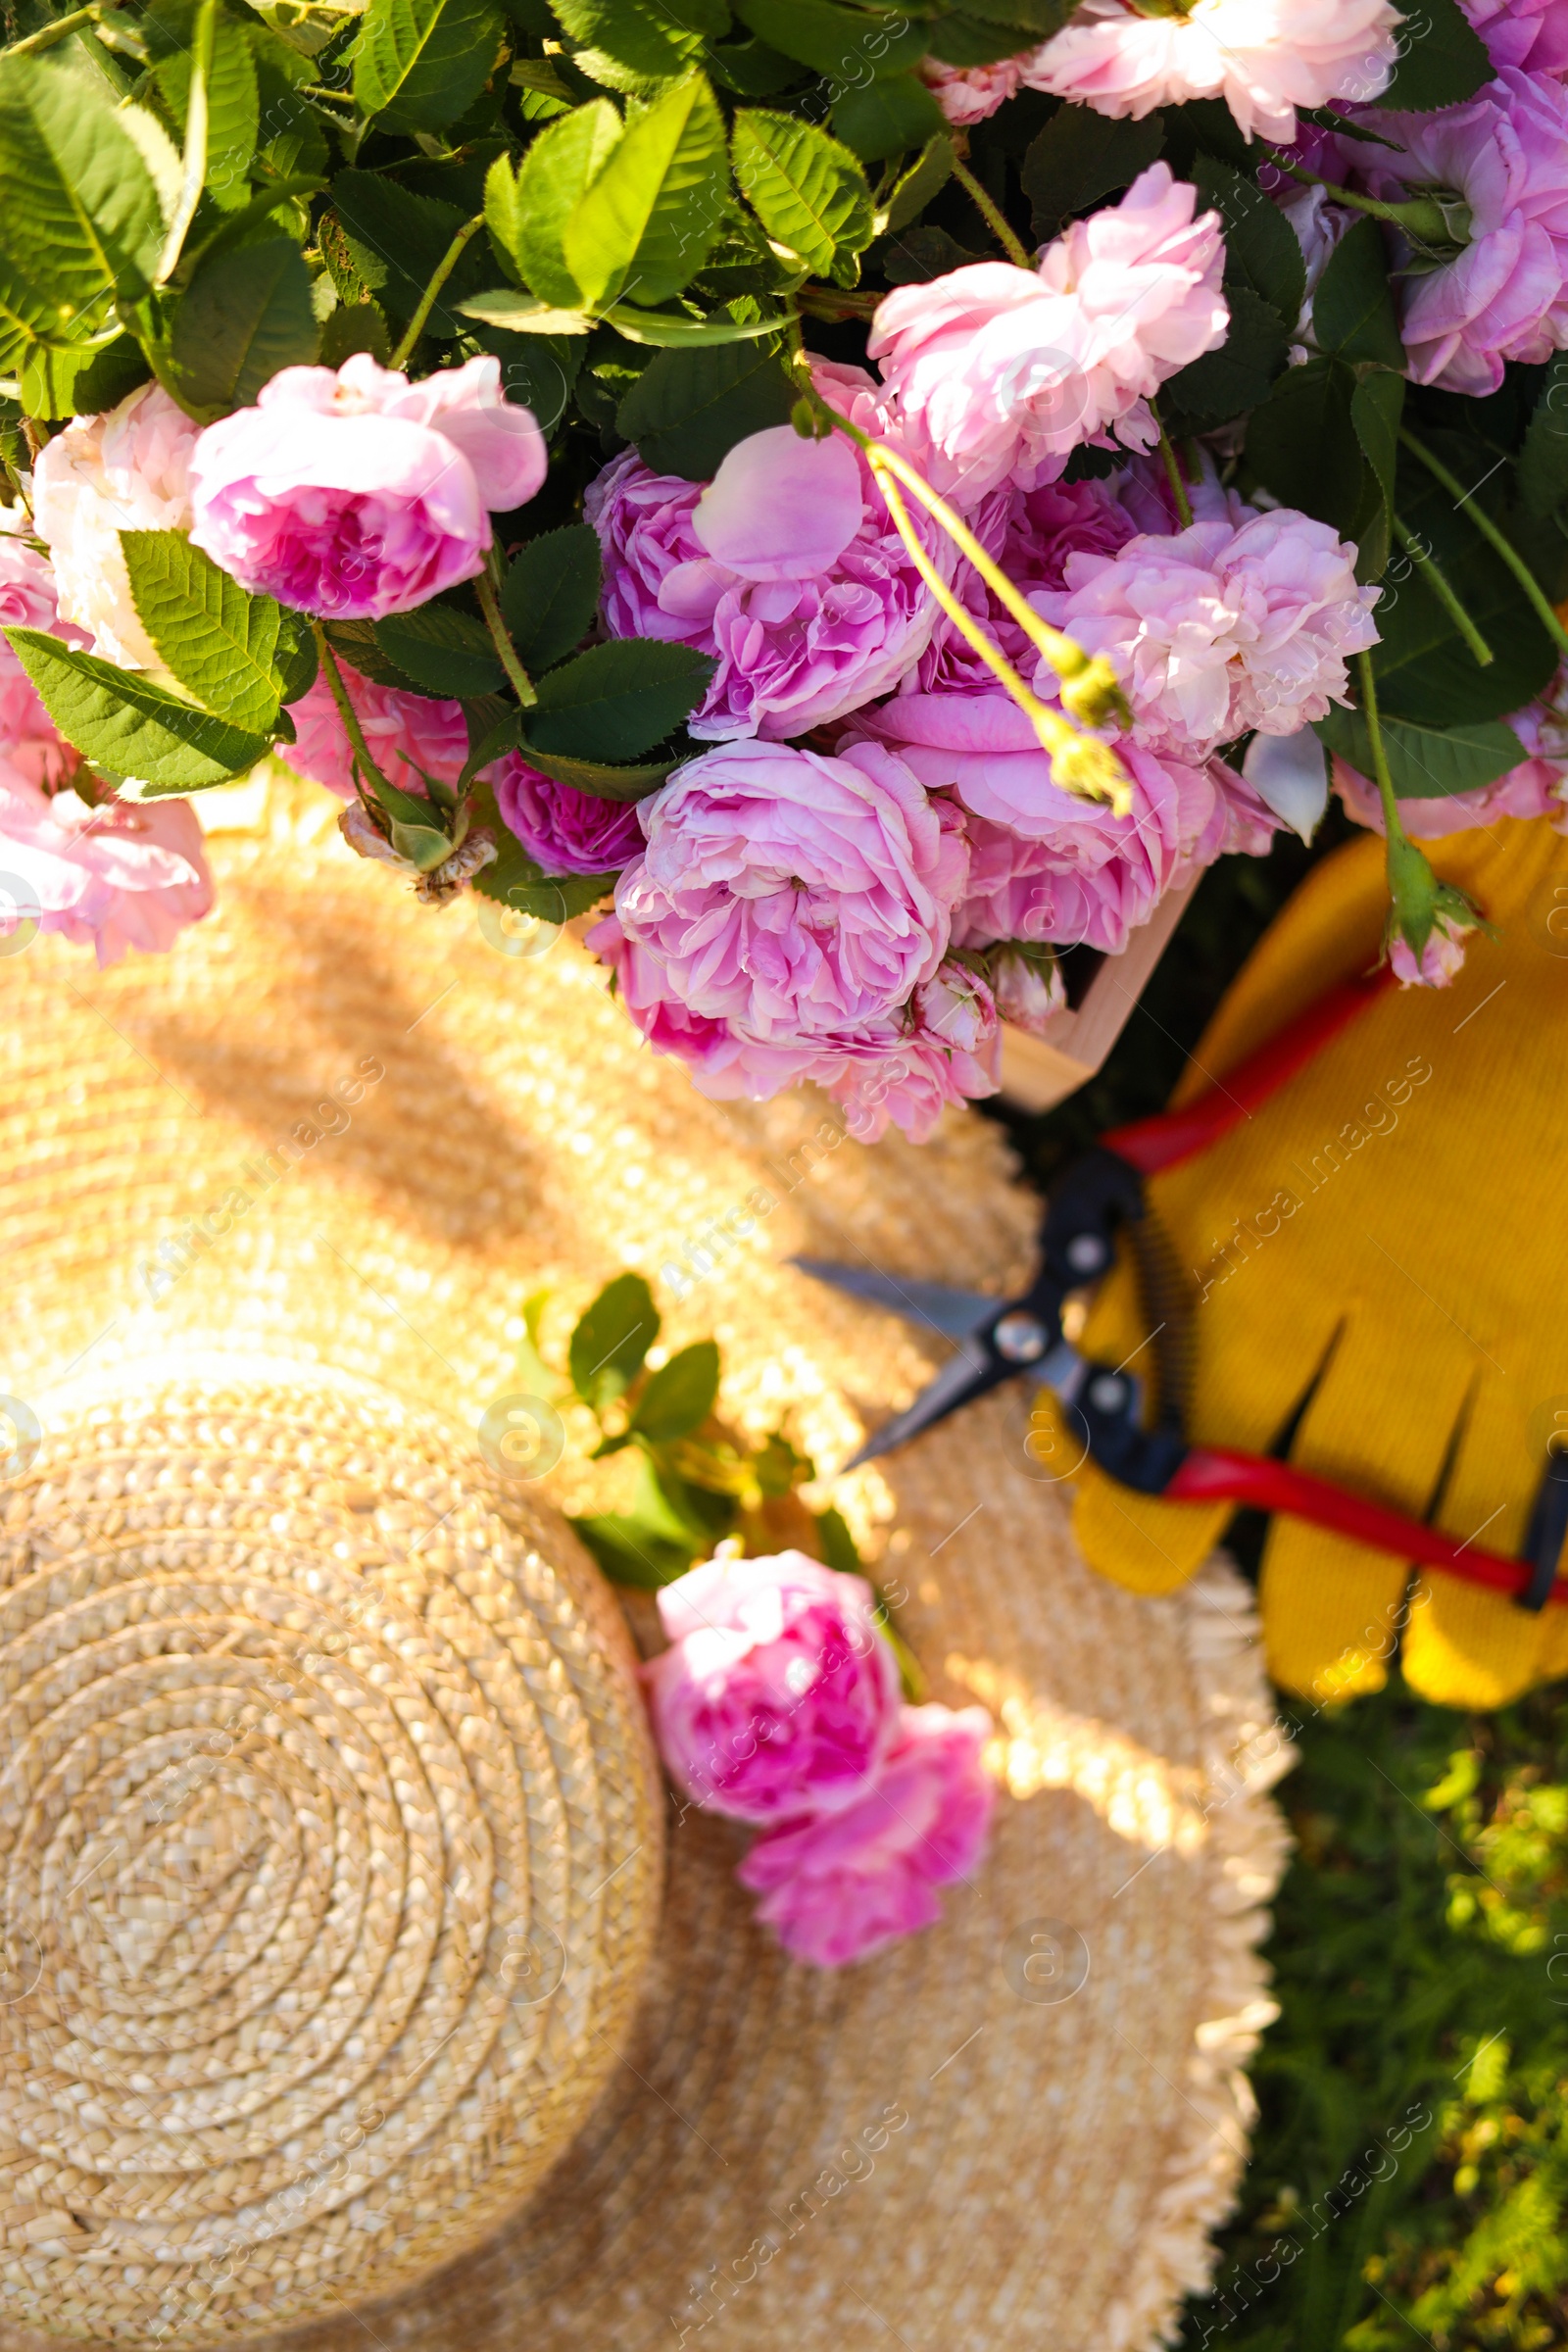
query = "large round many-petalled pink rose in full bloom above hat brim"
xmin=615 ymin=743 xmax=968 ymax=1047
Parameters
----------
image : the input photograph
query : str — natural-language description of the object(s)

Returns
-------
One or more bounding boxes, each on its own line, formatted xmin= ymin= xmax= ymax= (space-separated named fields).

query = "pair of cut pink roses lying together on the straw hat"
xmin=644 ymin=1552 xmax=995 ymax=1969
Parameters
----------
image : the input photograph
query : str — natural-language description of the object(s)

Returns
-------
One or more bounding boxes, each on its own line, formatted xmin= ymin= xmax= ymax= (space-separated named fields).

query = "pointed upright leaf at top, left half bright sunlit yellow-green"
xmin=562 ymin=73 xmax=729 ymax=311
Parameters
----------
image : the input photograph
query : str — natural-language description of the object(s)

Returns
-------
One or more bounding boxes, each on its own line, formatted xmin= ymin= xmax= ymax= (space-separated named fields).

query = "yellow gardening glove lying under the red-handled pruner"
xmin=1062 ymin=821 xmax=1568 ymax=1707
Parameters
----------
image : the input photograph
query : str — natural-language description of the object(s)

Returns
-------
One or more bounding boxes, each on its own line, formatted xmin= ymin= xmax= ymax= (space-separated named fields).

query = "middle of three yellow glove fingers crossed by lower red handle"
xmin=1260 ymin=1322 xmax=1474 ymax=1705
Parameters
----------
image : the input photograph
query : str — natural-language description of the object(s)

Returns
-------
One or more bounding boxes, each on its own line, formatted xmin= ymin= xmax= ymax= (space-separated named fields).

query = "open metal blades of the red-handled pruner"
xmin=792 ymin=1258 xmax=1084 ymax=1470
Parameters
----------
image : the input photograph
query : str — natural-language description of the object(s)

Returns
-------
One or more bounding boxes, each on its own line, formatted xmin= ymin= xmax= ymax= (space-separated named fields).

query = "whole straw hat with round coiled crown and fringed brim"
xmin=0 ymin=778 xmax=1289 ymax=2352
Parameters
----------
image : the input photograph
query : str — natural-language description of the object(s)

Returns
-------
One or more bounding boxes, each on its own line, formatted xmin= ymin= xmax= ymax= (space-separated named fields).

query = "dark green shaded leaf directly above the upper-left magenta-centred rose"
xmin=170 ymin=237 xmax=319 ymax=416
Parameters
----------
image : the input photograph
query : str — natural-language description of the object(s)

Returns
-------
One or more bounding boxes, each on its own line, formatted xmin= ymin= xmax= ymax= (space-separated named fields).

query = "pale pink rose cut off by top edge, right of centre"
xmin=1025 ymin=0 xmax=1401 ymax=143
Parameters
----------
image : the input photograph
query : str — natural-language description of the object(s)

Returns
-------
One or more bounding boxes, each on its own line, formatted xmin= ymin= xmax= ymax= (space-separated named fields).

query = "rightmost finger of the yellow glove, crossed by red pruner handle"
xmin=1403 ymin=1366 xmax=1568 ymax=1707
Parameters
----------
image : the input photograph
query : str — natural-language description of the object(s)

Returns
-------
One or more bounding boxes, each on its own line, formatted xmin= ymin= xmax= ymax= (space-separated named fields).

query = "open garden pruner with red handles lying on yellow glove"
xmin=795 ymin=974 xmax=1568 ymax=1609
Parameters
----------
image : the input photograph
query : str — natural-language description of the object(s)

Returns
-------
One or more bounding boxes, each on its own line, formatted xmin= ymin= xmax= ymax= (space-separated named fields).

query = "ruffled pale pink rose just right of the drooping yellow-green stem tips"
xmin=1032 ymin=508 xmax=1378 ymax=760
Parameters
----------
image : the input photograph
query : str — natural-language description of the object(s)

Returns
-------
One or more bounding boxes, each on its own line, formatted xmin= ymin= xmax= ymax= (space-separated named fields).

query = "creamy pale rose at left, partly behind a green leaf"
xmin=33 ymin=383 xmax=202 ymax=670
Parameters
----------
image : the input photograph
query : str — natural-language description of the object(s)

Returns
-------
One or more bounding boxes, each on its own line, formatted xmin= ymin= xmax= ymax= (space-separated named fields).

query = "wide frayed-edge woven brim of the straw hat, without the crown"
xmin=0 ymin=790 xmax=1286 ymax=2352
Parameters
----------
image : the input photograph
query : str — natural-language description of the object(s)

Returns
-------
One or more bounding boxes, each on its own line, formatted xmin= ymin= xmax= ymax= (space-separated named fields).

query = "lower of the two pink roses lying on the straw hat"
xmin=736 ymin=1705 xmax=997 ymax=1969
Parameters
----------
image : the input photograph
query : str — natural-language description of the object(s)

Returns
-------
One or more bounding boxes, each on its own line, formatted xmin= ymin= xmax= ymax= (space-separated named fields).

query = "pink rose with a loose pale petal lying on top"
xmin=583 ymin=363 xmax=956 ymax=741
